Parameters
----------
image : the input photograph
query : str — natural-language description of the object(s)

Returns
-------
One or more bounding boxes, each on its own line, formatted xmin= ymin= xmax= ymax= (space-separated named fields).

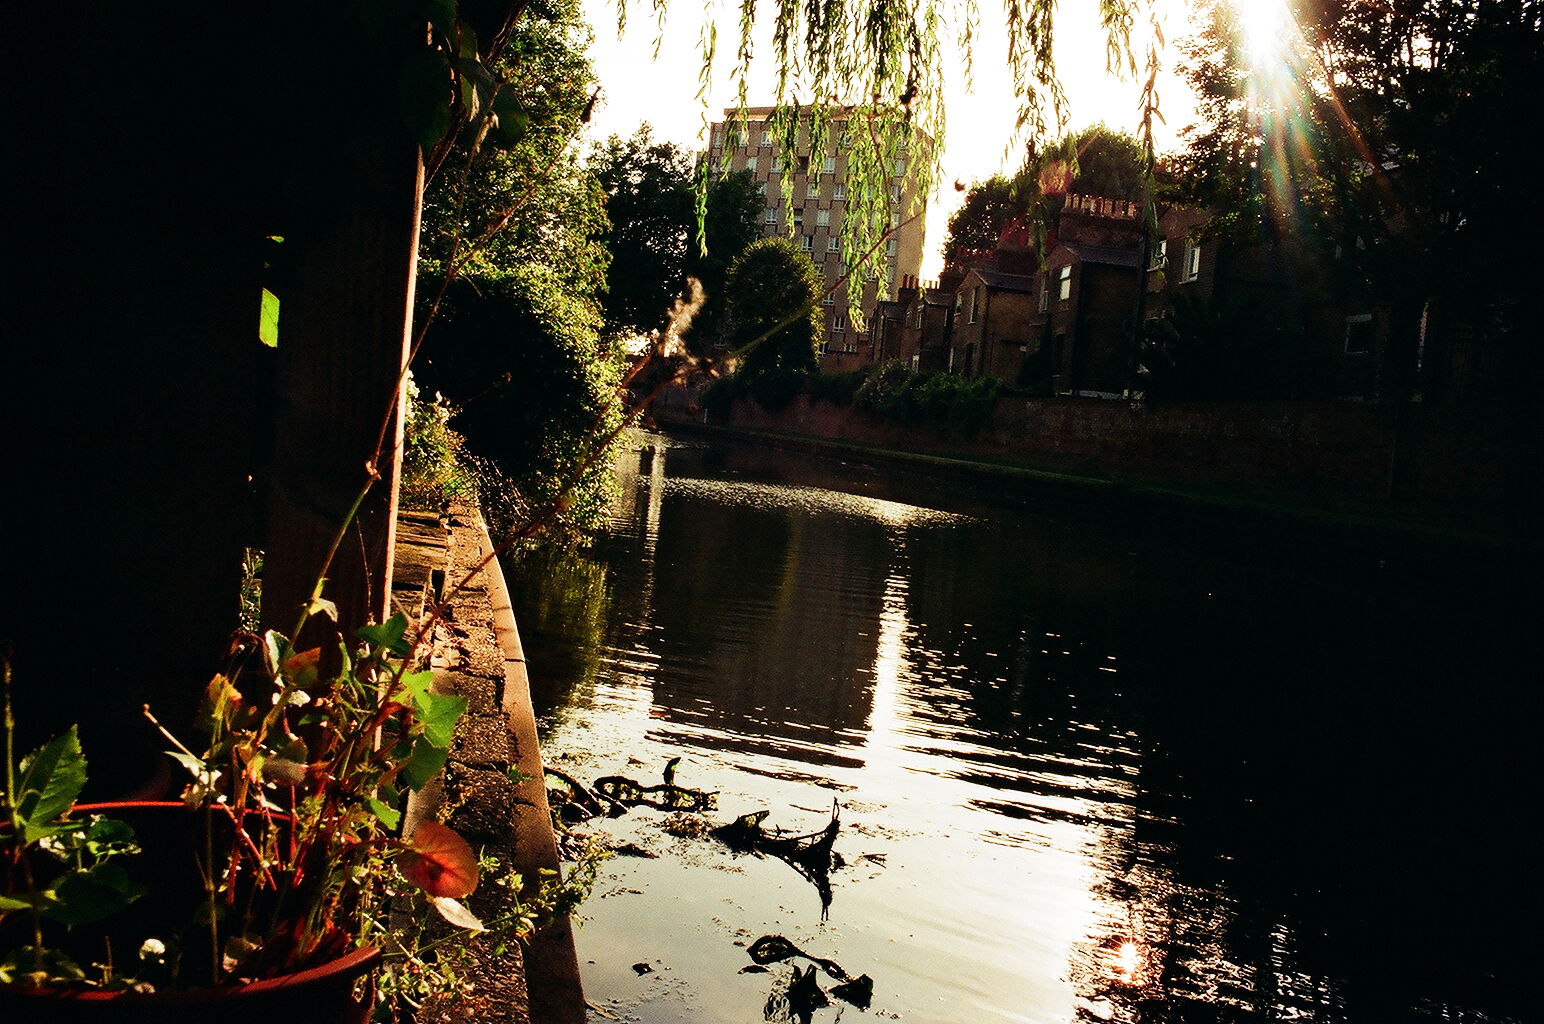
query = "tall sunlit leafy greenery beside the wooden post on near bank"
xmin=415 ymin=0 xmax=622 ymax=534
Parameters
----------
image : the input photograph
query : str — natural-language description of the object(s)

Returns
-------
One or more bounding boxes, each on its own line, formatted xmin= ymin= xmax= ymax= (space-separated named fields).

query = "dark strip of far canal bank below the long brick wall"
xmin=659 ymin=417 xmax=1544 ymax=576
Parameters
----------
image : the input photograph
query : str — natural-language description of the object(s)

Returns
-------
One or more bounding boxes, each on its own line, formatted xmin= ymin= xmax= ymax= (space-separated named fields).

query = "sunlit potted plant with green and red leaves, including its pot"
xmin=0 ymin=599 xmax=534 ymax=1022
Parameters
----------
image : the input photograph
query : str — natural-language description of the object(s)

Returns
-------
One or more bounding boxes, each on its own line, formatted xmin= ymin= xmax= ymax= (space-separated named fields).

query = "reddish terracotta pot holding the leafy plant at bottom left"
xmin=0 ymin=802 xmax=381 ymax=1024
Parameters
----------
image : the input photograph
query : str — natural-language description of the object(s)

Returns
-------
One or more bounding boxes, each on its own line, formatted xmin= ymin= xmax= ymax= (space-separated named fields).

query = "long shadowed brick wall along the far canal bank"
xmin=733 ymin=397 xmax=1536 ymax=519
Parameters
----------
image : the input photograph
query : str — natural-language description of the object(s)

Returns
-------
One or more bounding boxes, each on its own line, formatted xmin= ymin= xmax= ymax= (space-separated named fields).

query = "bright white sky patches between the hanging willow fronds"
xmin=584 ymin=0 xmax=1194 ymax=278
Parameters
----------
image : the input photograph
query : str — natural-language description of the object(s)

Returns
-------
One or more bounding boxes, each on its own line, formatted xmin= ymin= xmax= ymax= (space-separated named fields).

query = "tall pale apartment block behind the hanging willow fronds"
xmin=709 ymin=107 xmax=931 ymax=372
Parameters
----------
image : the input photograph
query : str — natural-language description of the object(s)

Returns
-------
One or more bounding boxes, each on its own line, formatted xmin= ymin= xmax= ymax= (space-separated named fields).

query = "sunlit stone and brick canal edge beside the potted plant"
xmin=392 ymin=504 xmax=585 ymax=1024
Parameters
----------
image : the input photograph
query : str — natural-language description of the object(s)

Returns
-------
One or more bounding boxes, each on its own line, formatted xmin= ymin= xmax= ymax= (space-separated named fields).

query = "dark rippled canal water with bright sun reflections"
xmin=508 ymin=434 xmax=1544 ymax=1024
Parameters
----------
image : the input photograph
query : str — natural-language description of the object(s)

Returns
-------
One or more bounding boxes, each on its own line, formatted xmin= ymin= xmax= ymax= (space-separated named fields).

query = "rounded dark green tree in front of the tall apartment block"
xmin=724 ymin=238 xmax=824 ymax=378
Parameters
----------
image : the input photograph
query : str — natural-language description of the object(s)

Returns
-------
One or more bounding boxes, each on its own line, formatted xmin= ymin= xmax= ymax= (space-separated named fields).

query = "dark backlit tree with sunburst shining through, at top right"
xmin=1177 ymin=0 xmax=1544 ymax=397
